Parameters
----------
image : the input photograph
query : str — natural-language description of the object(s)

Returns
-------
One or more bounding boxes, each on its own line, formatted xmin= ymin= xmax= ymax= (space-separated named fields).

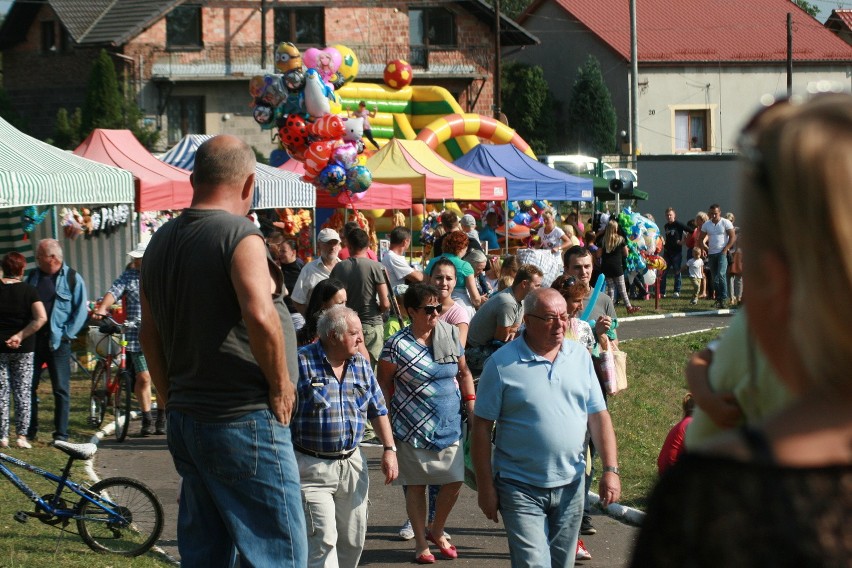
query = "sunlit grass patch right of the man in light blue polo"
xmin=592 ymin=331 xmax=720 ymax=510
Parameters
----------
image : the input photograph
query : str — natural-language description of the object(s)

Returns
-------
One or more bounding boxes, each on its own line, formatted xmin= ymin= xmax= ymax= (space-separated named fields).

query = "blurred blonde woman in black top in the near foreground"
xmin=633 ymin=94 xmax=852 ymax=567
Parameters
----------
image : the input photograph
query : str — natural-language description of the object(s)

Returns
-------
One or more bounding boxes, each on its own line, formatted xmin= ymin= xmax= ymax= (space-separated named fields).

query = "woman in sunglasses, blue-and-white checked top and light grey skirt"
xmin=378 ymin=283 xmax=476 ymax=564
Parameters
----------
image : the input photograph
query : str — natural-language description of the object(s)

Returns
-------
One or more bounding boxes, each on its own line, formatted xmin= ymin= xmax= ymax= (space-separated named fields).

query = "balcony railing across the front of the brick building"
xmin=151 ymin=45 xmax=494 ymax=79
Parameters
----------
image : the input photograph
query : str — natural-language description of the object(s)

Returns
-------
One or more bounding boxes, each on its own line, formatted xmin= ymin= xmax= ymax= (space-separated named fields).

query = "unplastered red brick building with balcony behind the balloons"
xmin=0 ymin=0 xmax=537 ymax=153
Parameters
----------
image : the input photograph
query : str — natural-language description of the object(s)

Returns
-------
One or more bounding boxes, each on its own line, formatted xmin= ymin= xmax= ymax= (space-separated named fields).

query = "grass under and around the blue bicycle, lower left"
xmin=0 ymin=372 xmax=172 ymax=568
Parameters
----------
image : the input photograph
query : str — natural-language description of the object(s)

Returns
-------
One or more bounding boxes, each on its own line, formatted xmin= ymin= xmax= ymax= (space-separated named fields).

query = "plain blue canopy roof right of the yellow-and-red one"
xmin=453 ymin=144 xmax=593 ymax=201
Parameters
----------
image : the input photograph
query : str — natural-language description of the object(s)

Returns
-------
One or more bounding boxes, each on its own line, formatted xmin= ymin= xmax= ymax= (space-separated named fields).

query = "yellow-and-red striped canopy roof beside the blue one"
xmin=367 ymin=138 xmax=506 ymax=201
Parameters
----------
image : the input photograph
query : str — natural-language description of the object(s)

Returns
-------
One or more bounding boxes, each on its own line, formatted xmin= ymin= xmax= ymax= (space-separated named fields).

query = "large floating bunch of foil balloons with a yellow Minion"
xmin=249 ymin=42 xmax=373 ymax=196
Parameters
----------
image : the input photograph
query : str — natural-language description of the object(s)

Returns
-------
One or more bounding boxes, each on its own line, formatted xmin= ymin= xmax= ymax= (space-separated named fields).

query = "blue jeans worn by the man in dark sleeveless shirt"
xmin=167 ymin=410 xmax=308 ymax=568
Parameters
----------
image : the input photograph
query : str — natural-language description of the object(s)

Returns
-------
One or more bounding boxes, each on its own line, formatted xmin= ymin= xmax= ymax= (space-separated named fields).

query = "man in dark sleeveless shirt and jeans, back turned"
xmin=140 ymin=136 xmax=307 ymax=568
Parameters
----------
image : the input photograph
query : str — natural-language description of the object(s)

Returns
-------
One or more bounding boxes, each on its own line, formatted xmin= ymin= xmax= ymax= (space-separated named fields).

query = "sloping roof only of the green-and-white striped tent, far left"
xmin=0 ymin=118 xmax=134 ymax=207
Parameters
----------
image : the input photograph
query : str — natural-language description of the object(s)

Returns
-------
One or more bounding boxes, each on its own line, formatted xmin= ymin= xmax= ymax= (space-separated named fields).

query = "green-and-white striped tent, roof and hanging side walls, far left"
xmin=0 ymin=118 xmax=134 ymax=297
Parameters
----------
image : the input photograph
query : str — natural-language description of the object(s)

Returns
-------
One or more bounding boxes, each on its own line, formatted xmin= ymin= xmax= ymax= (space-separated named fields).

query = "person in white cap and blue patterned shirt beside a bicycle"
xmin=94 ymin=242 xmax=166 ymax=437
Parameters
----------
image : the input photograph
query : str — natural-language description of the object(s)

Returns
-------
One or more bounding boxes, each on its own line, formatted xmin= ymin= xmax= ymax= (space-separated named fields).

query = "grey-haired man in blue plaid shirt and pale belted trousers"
xmin=291 ymin=305 xmax=399 ymax=568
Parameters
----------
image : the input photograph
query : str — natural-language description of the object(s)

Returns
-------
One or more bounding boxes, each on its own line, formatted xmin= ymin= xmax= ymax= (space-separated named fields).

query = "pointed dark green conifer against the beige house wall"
xmin=567 ymin=55 xmax=616 ymax=156
